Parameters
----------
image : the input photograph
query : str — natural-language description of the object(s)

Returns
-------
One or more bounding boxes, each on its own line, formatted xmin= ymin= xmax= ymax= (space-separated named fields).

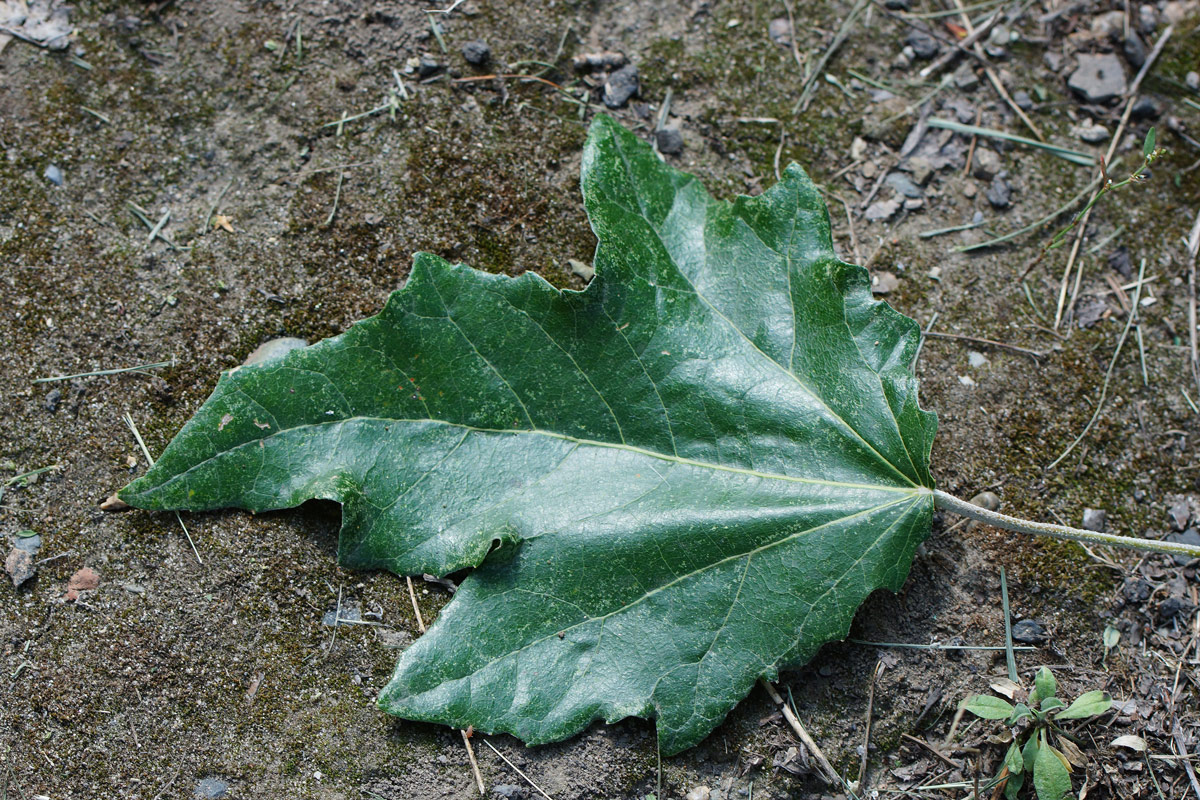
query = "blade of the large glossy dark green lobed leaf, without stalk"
xmin=121 ymin=116 xmax=936 ymax=753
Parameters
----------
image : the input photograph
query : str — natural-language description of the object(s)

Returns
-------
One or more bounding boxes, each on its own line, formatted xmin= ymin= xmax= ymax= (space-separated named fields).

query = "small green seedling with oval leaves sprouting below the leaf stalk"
xmin=960 ymin=667 xmax=1112 ymax=800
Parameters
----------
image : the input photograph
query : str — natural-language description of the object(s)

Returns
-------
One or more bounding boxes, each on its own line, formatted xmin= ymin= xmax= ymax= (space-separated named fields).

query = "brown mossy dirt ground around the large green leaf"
xmin=0 ymin=0 xmax=1200 ymax=800
